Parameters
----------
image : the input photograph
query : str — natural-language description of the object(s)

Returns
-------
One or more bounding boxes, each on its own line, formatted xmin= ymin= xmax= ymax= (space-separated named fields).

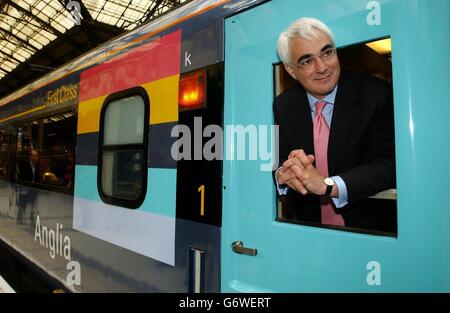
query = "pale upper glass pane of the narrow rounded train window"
xmin=103 ymin=96 xmax=145 ymax=145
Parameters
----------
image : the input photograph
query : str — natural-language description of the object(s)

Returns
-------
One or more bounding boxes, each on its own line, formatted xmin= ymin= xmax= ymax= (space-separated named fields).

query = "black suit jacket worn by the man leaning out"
xmin=274 ymin=71 xmax=396 ymax=231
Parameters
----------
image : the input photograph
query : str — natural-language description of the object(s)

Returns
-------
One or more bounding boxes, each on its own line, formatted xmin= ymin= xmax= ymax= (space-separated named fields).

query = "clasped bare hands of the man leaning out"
xmin=277 ymin=149 xmax=327 ymax=195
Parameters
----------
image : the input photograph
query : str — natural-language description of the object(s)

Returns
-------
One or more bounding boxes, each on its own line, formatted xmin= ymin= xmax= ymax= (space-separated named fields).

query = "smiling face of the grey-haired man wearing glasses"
xmin=285 ymin=31 xmax=340 ymax=99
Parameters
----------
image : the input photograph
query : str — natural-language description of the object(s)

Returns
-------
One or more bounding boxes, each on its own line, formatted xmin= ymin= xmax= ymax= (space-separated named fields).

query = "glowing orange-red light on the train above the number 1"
xmin=178 ymin=69 xmax=206 ymax=110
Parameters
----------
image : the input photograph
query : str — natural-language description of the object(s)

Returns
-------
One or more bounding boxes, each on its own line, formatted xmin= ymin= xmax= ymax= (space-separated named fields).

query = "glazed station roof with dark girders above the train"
xmin=0 ymin=0 xmax=189 ymax=98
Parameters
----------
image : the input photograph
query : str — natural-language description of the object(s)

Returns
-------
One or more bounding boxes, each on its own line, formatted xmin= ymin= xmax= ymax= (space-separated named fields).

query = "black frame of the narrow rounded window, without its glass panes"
xmin=97 ymin=86 xmax=150 ymax=209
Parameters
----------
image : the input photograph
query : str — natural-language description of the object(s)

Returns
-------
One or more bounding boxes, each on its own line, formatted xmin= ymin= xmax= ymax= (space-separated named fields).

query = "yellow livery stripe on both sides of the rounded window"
xmin=77 ymin=74 xmax=180 ymax=134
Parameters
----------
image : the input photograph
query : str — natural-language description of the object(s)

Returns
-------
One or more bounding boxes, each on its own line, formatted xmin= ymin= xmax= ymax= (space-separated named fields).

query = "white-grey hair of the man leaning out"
xmin=277 ymin=17 xmax=335 ymax=64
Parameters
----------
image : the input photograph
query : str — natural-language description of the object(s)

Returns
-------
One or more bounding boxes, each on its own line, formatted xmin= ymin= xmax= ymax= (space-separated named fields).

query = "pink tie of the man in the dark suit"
xmin=313 ymin=101 xmax=344 ymax=226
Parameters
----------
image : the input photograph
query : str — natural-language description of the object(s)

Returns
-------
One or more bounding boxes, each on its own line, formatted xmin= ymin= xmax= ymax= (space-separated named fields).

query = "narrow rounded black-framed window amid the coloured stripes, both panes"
xmin=97 ymin=87 xmax=149 ymax=208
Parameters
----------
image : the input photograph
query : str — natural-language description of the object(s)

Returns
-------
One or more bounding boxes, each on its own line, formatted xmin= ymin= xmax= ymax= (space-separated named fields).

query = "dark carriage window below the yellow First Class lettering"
xmin=16 ymin=112 xmax=75 ymax=190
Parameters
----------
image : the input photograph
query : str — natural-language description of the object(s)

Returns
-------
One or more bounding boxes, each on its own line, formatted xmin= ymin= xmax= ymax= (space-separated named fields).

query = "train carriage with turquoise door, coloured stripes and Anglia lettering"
xmin=0 ymin=0 xmax=450 ymax=293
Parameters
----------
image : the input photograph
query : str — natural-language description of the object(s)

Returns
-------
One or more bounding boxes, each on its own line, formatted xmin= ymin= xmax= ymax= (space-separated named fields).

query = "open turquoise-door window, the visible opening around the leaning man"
xmin=274 ymin=38 xmax=397 ymax=236
